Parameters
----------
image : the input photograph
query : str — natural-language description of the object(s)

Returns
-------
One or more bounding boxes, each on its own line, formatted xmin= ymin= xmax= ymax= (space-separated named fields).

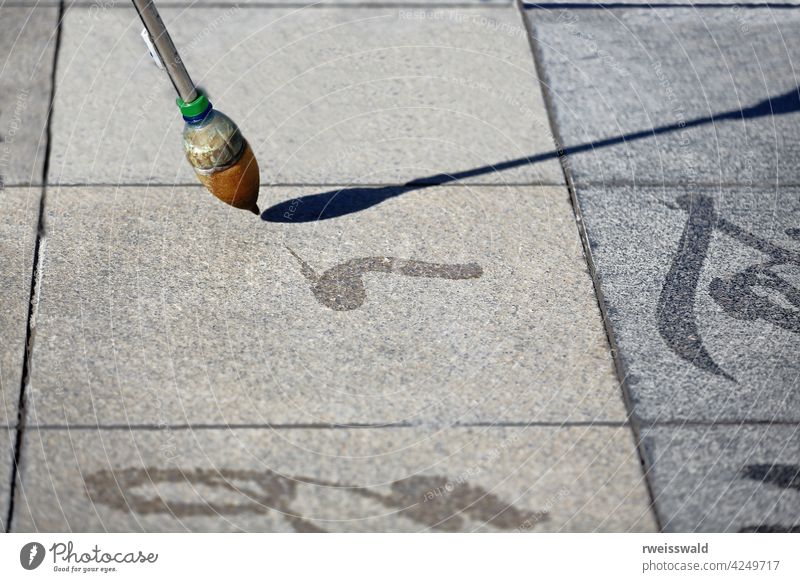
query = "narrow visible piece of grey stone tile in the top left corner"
xmin=0 ymin=6 xmax=58 ymax=187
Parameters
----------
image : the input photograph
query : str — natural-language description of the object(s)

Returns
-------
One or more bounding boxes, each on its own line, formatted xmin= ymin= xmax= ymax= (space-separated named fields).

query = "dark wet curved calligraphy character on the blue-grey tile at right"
xmin=657 ymin=195 xmax=800 ymax=380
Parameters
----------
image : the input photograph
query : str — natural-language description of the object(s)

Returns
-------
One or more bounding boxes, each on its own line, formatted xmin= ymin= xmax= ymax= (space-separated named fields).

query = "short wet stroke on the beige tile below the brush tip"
xmin=286 ymin=247 xmax=483 ymax=311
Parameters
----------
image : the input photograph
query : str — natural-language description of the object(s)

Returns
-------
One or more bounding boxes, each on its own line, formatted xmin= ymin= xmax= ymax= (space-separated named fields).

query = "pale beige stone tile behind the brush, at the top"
xmin=50 ymin=6 xmax=563 ymax=184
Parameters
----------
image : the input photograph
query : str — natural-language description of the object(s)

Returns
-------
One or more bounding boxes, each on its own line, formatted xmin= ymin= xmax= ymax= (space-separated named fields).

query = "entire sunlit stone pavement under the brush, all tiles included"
xmin=0 ymin=0 xmax=800 ymax=532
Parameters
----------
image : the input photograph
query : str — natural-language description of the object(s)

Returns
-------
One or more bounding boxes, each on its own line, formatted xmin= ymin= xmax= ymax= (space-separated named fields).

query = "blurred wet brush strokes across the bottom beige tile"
xmin=84 ymin=467 xmax=548 ymax=532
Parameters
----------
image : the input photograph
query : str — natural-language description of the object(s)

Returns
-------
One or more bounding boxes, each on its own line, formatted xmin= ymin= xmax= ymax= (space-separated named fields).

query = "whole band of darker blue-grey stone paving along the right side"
xmin=526 ymin=6 xmax=800 ymax=531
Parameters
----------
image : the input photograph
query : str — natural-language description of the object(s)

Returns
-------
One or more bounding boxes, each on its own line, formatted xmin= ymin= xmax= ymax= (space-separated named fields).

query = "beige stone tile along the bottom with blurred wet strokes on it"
xmin=13 ymin=427 xmax=655 ymax=532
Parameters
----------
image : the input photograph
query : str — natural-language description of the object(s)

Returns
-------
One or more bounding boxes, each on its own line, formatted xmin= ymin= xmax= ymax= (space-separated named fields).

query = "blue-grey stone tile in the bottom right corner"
xmin=643 ymin=425 xmax=800 ymax=532
